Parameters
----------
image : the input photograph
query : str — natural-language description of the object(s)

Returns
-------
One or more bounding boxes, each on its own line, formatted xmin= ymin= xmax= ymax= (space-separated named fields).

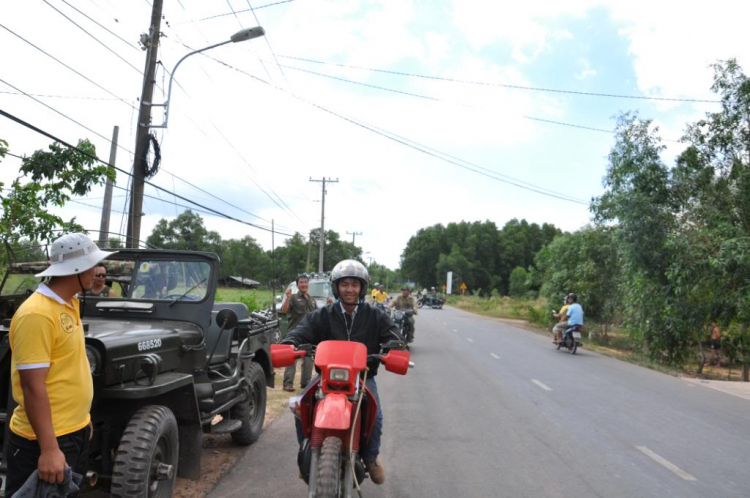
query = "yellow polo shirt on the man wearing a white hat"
xmin=10 ymin=284 xmax=94 ymax=440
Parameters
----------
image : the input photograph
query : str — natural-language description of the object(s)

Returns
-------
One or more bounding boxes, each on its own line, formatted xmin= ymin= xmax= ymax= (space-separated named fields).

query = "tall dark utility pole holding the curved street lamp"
xmin=125 ymin=0 xmax=164 ymax=248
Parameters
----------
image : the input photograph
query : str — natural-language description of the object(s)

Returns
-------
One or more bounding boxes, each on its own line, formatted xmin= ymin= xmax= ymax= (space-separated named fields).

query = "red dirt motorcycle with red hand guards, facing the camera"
xmin=271 ymin=341 xmax=414 ymax=498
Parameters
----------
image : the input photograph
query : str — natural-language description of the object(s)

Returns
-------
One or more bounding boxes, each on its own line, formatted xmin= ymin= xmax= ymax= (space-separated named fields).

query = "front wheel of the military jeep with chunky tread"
xmin=110 ymin=405 xmax=179 ymax=498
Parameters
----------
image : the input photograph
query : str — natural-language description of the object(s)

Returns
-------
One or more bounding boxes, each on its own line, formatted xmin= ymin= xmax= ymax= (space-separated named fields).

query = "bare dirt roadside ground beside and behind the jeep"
xmin=83 ymin=368 xmax=301 ymax=498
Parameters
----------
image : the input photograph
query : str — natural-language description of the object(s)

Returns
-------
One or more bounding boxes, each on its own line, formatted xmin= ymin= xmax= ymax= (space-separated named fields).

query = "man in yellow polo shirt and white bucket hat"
xmin=5 ymin=233 xmax=114 ymax=496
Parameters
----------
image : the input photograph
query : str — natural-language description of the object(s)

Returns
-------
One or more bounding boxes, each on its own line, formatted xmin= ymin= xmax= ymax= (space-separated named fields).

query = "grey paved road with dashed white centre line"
xmin=211 ymin=308 xmax=750 ymax=498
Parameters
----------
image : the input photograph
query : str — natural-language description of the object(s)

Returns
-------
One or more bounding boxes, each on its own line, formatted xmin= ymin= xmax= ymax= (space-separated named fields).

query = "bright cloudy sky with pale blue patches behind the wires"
xmin=0 ymin=0 xmax=750 ymax=267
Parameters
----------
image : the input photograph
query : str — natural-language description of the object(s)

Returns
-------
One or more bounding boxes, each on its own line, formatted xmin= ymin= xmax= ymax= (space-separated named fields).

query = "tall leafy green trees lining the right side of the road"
xmin=536 ymin=60 xmax=750 ymax=380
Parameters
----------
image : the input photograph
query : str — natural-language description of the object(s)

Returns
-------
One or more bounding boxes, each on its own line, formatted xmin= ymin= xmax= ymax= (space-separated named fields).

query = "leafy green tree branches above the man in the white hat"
xmin=0 ymin=140 xmax=113 ymax=241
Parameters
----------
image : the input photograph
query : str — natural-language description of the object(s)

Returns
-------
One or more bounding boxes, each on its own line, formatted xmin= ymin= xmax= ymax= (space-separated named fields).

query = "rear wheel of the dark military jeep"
xmin=229 ymin=360 xmax=267 ymax=446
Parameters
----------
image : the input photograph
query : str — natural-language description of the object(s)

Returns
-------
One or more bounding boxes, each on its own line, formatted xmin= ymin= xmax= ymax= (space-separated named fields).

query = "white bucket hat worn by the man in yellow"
xmin=36 ymin=233 xmax=117 ymax=277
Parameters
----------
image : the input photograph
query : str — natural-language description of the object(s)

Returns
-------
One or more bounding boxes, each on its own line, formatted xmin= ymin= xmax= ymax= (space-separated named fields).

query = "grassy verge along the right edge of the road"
xmin=448 ymin=295 xmax=741 ymax=381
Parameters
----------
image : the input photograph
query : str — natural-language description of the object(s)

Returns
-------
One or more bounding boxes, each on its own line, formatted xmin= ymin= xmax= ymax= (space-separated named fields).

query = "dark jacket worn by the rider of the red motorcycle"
xmin=282 ymin=301 xmax=404 ymax=377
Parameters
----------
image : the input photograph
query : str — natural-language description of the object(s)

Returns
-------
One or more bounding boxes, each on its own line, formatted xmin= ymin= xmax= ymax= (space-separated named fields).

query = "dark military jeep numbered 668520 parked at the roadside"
xmin=0 ymin=249 xmax=278 ymax=498
